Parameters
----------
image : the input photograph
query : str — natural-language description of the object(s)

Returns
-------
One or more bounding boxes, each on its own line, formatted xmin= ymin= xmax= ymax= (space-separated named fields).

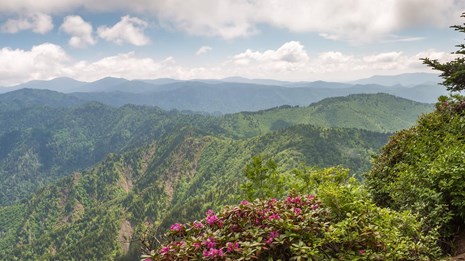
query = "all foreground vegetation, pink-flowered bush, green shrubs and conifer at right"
xmin=143 ymin=14 xmax=465 ymax=260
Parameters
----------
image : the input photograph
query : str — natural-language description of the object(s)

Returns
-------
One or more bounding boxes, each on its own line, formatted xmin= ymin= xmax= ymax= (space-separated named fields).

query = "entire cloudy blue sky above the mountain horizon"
xmin=0 ymin=0 xmax=465 ymax=86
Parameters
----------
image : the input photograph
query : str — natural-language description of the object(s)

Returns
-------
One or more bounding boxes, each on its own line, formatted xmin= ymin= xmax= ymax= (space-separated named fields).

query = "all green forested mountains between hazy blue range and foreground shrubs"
xmin=0 ymin=90 xmax=432 ymax=260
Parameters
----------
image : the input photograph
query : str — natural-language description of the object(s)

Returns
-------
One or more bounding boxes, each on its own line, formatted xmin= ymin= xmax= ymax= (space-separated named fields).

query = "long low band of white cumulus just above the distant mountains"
xmin=0 ymin=41 xmax=454 ymax=86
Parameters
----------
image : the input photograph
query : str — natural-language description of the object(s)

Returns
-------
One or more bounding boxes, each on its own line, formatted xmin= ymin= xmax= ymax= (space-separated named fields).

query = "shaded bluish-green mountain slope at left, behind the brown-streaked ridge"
xmin=0 ymin=100 xmax=216 ymax=205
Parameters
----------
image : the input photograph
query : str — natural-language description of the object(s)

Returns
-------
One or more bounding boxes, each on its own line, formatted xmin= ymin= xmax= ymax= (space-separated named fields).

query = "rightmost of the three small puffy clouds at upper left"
xmin=97 ymin=15 xmax=150 ymax=46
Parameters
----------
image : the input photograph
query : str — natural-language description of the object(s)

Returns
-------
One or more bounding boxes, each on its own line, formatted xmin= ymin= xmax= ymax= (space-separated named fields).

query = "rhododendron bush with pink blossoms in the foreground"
xmin=143 ymin=186 xmax=438 ymax=260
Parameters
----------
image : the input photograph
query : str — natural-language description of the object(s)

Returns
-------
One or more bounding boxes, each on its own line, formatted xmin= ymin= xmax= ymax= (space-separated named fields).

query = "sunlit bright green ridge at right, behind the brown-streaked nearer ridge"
xmin=221 ymin=93 xmax=433 ymax=136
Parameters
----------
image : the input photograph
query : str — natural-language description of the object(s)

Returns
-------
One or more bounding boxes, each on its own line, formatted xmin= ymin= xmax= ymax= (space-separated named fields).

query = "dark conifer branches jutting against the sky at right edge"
xmin=422 ymin=13 xmax=465 ymax=91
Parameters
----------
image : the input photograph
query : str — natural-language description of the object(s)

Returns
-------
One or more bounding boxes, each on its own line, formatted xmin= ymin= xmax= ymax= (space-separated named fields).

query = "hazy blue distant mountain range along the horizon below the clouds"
xmin=0 ymin=74 xmax=447 ymax=114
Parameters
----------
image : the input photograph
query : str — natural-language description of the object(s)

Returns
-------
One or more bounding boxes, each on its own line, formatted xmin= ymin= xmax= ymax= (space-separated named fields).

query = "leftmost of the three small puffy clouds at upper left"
xmin=1 ymin=13 xmax=53 ymax=34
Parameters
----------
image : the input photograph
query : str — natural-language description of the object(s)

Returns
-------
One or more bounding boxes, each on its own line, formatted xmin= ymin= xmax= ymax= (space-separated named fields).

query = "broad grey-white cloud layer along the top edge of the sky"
xmin=0 ymin=0 xmax=465 ymax=43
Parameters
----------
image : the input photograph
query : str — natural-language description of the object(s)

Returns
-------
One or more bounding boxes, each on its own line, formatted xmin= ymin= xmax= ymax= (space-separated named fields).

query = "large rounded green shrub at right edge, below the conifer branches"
xmin=366 ymin=93 xmax=465 ymax=249
